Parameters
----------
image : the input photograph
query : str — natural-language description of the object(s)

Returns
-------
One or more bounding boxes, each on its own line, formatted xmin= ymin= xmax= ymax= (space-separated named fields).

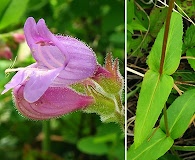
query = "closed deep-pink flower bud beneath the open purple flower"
xmin=13 ymin=84 xmax=94 ymax=120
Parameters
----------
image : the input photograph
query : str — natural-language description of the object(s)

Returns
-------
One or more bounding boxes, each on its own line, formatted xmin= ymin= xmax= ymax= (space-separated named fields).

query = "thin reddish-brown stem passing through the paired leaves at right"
xmin=159 ymin=0 xmax=175 ymax=137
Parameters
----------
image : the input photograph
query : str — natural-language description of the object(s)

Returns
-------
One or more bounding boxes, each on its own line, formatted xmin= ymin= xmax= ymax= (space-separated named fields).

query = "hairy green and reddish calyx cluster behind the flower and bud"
xmin=84 ymin=54 xmax=124 ymax=127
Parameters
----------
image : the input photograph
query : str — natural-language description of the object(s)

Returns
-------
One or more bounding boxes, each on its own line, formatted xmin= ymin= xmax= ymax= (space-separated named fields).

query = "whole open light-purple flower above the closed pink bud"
xmin=2 ymin=17 xmax=97 ymax=103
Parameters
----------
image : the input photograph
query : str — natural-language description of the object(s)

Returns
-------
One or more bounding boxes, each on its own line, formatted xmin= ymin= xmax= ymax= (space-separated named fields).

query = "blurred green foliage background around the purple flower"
xmin=0 ymin=0 xmax=125 ymax=160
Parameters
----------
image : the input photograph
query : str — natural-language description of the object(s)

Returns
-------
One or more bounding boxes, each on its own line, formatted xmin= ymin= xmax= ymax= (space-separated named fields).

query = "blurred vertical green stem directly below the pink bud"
xmin=42 ymin=120 xmax=50 ymax=152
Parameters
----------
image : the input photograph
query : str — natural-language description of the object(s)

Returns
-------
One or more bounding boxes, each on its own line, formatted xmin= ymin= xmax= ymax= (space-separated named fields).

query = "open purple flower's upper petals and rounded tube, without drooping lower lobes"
xmin=24 ymin=18 xmax=97 ymax=85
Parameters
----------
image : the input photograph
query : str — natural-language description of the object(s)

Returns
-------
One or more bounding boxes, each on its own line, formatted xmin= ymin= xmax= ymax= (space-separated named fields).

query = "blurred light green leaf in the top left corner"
xmin=0 ymin=0 xmax=29 ymax=30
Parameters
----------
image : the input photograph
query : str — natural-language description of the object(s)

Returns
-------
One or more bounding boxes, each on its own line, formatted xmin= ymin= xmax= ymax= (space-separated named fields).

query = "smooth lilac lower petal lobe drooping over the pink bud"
xmin=24 ymin=68 xmax=63 ymax=103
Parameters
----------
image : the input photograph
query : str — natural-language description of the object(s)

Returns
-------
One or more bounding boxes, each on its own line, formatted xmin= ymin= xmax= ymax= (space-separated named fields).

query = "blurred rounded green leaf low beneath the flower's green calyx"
xmin=77 ymin=137 xmax=108 ymax=155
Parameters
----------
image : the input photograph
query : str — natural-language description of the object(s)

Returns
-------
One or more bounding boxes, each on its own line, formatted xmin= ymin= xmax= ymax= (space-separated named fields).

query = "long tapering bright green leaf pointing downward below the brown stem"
xmin=134 ymin=70 xmax=173 ymax=147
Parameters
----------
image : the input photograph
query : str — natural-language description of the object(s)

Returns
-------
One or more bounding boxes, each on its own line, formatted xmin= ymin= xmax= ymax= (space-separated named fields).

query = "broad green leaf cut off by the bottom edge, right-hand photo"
xmin=127 ymin=128 xmax=173 ymax=160
